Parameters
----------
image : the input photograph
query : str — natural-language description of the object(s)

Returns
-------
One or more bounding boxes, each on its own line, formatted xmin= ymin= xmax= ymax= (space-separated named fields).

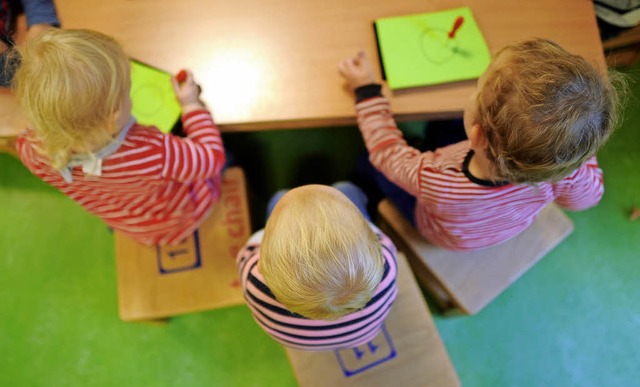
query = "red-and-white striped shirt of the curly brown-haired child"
xmin=356 ymin=97 xmax=604 ymax=250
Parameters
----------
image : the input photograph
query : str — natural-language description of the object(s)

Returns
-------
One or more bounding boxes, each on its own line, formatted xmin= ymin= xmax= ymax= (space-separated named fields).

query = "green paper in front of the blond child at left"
xmin=130 ymin=60 xmax=181 ymax=133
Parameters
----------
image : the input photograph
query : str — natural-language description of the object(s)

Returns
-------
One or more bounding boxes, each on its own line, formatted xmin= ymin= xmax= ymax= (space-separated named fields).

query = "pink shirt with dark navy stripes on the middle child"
xmin=237 ymin=226 xmax=398 ymax=351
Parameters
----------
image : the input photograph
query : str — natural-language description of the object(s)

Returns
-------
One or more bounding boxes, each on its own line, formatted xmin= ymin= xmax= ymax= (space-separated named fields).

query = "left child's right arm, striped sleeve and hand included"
xmin=163 ymin=71 xmax=225 ymax=182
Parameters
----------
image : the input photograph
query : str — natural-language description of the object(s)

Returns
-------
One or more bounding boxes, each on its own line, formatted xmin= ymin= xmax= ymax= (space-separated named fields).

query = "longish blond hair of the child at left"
xmin=14 ymin=29 xmax=130 ymax=169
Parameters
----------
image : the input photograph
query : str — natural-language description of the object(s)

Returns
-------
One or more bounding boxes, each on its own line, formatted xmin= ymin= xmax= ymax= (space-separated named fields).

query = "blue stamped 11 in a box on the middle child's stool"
xmin=334 ymin=324 xmax=397 ymax=377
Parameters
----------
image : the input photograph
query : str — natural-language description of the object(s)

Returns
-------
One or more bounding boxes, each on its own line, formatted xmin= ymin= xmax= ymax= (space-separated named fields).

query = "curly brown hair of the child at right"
xmin=474 ymin=39 xmax=624 ymax=183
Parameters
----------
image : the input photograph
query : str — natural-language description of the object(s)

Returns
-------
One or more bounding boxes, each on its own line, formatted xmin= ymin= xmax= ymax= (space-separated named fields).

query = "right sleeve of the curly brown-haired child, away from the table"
xmin=553 ymin=156 xmax=604 ymax=211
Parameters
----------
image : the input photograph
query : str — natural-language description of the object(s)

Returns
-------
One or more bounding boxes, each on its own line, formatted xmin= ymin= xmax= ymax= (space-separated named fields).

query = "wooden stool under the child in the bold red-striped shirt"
xmin=115 ymin=167 xmax=251 ymax=321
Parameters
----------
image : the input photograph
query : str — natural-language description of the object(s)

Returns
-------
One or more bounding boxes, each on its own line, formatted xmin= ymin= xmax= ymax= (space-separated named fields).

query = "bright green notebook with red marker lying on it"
xmin=375 ymin=7 xmax=491 ymax=89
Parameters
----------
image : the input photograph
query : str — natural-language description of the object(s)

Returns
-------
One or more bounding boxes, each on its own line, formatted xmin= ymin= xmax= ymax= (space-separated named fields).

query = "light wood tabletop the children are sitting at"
xmin=2 ymin=0 xmax=605 ymax=138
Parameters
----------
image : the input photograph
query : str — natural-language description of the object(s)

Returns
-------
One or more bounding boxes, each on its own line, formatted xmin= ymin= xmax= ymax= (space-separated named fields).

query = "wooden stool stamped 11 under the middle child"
xmin=286 ymin=254 xmax=460 ymax=387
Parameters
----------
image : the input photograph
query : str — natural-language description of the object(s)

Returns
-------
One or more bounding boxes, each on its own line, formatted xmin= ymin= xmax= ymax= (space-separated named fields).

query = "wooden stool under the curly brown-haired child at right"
xmin=378 ymin=199 xmax=573 ymax=314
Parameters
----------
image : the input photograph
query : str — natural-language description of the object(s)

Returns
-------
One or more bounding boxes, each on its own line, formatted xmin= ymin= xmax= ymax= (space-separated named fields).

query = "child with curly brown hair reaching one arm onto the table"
xmin=339 ymin=39 xmax=619 ymax=250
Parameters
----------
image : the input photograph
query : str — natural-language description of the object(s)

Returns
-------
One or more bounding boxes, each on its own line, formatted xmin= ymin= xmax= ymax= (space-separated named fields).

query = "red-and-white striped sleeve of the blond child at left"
xmin=162 ymin=110 xmax=225 ymax=182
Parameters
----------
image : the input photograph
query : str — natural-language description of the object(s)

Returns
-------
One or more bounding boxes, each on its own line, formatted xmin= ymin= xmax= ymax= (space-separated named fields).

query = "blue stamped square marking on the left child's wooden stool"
xmin=156 ymin=230 xmax=202 ymax=274
